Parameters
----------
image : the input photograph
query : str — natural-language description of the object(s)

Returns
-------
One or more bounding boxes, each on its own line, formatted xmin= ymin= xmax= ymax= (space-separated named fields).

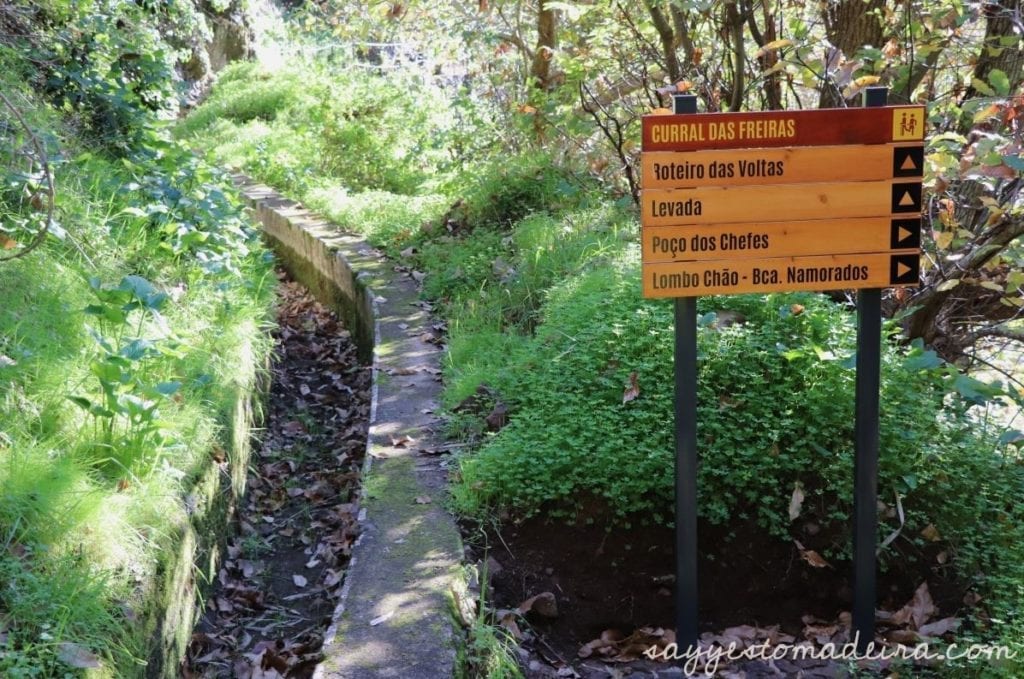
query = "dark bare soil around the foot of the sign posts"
xmin=467 ymin=518 xmax=966 ymax=677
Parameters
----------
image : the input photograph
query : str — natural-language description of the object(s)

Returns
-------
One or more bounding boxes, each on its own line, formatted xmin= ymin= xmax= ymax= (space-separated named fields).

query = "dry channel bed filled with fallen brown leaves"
xmin=182 ymin=277 xmax=371 ymax=679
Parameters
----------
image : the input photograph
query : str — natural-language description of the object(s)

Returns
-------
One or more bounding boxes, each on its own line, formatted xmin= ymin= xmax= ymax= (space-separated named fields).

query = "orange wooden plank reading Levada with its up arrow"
xmin=640 ymin=181 xmax=922 ymax=226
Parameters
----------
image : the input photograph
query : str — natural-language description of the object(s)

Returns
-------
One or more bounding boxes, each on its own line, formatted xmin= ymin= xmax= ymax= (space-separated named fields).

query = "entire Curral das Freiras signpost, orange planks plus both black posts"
xmin=641 ymin=88 xmax=926 ymax=651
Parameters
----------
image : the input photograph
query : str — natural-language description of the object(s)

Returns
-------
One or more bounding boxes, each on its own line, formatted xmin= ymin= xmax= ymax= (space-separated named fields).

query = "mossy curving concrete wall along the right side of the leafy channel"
xmin=236 ymin=176 xmax=464 ymax=679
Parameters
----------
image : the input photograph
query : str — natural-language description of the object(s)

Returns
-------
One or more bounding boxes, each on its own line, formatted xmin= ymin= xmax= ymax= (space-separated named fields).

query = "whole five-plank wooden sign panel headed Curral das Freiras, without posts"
xmin=641 ymin=105 xmax=925 ymax=297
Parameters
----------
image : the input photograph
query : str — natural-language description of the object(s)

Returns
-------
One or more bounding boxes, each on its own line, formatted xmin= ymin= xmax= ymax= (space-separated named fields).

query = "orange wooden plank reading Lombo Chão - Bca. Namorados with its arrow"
xmin=643 ymin=250 xmax=921 ymax=298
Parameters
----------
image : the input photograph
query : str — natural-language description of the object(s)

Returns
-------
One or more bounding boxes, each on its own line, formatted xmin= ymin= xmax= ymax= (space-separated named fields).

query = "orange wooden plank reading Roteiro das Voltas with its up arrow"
xmin=641 ymin=143 xmax=925 ymax=188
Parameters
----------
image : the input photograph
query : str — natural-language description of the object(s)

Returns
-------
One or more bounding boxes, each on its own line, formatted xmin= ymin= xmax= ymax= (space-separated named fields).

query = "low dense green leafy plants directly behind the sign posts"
xmin=456 ymin=255 xmax=1011 ymax=555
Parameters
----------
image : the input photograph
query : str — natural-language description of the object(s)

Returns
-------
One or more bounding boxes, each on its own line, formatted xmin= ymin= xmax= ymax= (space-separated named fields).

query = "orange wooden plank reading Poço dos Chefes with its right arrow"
xmin=640 ymin=217 xmax=921 ymax=262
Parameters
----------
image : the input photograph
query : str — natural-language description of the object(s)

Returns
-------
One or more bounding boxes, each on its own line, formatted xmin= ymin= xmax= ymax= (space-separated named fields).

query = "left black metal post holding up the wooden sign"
xmin=673 ymin=94 xmax=698 ymax=652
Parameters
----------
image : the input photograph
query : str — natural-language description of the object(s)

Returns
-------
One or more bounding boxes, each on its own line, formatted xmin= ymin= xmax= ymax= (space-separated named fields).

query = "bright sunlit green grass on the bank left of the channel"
xmin=0 ymin=81 xmax=274 ymax=678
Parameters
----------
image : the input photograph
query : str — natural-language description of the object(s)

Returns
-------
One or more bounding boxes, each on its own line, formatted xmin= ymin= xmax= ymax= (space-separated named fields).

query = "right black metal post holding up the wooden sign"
xmin=853 ymin=87 xmax=888 ymax=652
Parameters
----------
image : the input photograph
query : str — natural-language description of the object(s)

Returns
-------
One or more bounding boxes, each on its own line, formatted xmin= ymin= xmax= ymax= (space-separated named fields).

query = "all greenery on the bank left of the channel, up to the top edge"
xmin=0 ymin=2 xmax=274 ymax=677
